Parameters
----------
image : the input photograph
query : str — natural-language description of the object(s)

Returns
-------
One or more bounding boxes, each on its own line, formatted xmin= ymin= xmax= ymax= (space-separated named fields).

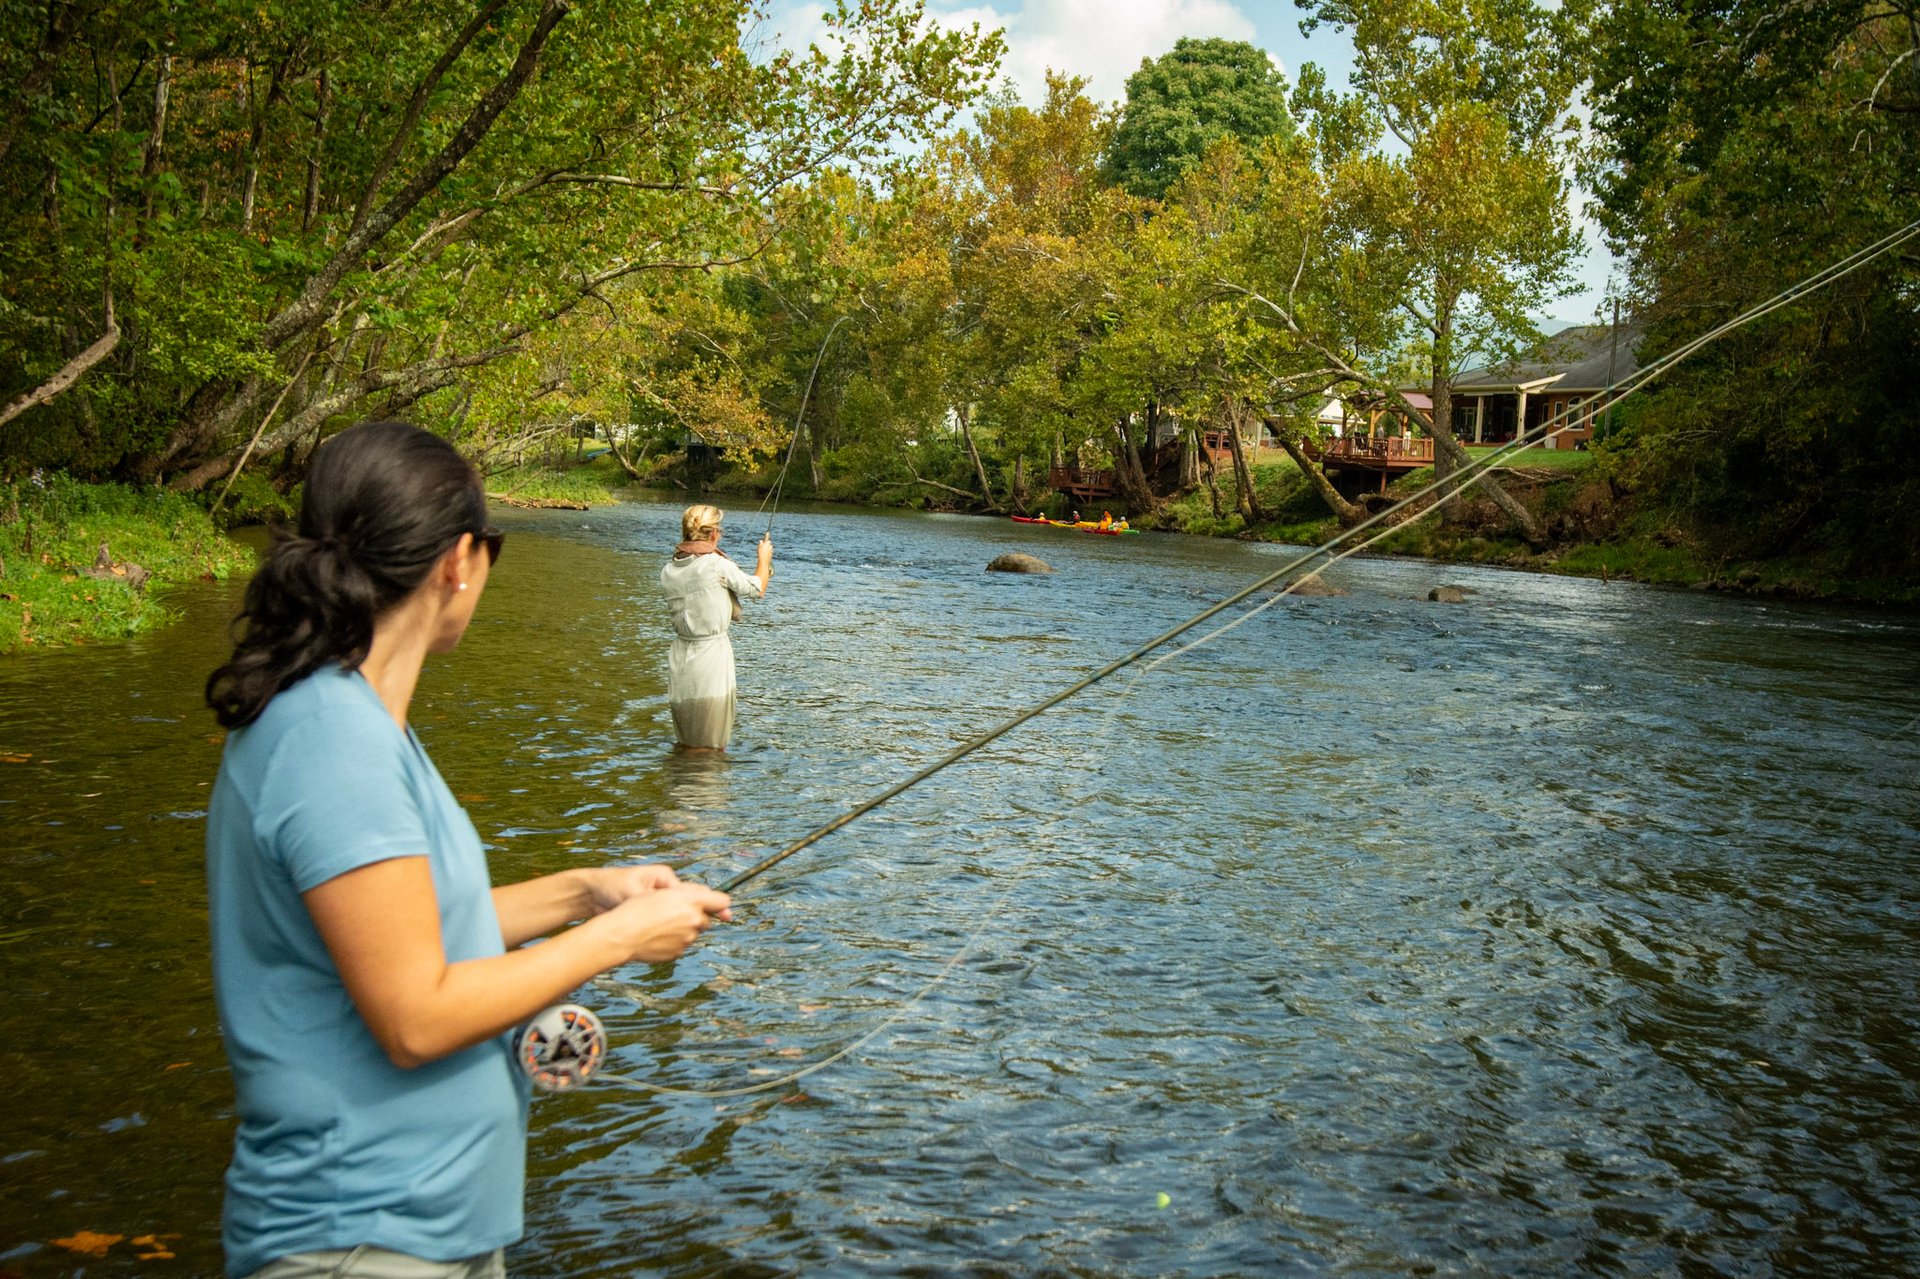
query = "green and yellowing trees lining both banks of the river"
xmin=0 ymin=0 xmax=1920 ymax=637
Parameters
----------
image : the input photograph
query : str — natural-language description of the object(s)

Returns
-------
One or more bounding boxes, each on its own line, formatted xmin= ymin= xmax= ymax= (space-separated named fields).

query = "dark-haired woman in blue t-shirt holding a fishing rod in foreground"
xmin=207 ymin=422 xmax=730 ymax=1279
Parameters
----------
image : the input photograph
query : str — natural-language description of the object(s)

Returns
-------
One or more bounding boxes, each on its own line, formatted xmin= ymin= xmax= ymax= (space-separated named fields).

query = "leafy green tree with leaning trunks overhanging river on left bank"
xmin=0 ymin=0 xmax=998 ymax=488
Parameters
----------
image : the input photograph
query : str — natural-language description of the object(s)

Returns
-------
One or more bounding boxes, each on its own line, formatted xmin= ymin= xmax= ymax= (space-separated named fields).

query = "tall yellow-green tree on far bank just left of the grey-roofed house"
xmin=1282 ymin=0 xmax=1580 ymax=543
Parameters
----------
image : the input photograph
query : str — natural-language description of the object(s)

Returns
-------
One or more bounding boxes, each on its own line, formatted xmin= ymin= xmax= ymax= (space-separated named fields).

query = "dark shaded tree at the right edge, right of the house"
xmin=1588 ymin=0 xmax=1920 ymax=574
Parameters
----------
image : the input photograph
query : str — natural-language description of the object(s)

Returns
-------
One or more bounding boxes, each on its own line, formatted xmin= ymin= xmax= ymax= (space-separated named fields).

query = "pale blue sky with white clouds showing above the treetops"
xmin=776 ymin=0 xmax=1613 ymax=323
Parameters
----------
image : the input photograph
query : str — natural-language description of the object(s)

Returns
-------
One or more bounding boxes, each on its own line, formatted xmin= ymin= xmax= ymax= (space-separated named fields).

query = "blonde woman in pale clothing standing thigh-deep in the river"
xmin=660 ymin=503 xmax=774 ymax=751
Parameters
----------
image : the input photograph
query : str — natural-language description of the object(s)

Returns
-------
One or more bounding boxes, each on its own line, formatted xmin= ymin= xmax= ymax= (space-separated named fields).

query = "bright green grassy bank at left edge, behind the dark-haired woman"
xmin=0 ymin=474 xmax=253 ymax=653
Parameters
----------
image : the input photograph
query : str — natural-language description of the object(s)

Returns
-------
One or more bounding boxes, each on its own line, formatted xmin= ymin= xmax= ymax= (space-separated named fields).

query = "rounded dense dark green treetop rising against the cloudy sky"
xmin=1106 ymin=38 xmax=1294 ymax=200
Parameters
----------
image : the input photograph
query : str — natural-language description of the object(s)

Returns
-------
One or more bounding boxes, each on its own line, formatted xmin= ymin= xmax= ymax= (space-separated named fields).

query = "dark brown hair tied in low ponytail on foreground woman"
xmin=207 ymin=422 xmax=486 ymax=728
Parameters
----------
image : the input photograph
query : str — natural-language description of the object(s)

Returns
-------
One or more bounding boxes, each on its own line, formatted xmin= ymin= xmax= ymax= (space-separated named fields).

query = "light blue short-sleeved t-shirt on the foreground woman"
xmin=207 ymin=666 xmax=528 ymax=1275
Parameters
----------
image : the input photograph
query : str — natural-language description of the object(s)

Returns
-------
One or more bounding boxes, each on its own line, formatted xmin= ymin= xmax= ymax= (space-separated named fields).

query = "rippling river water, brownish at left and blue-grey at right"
xmin=0 ymin=505 xmax=1920 ymax=1277
